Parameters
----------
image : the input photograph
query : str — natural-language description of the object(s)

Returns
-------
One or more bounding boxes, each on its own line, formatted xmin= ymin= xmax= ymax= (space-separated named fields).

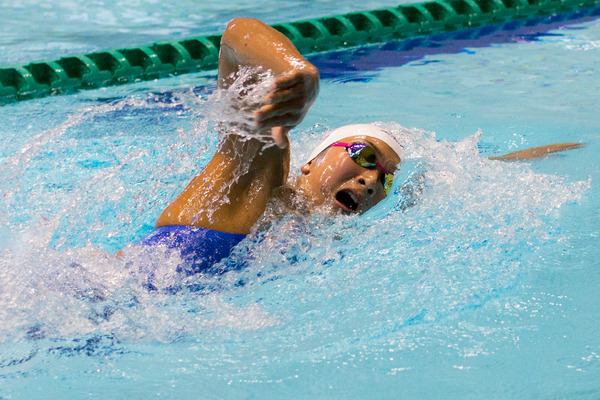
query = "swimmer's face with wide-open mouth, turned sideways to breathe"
xmin=299 ymin=136 xmax=400 ymax=214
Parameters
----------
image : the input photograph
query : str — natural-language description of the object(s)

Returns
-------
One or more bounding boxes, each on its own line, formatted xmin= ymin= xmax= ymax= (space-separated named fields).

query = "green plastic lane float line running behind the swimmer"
xmin=0 ymin=0 xmax=600 ymax=105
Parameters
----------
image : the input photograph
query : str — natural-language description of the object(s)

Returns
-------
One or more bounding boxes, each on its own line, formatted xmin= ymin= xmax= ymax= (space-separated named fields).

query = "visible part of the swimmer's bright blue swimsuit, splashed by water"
xmin=141 ymin=225 xmax=246 ymax=275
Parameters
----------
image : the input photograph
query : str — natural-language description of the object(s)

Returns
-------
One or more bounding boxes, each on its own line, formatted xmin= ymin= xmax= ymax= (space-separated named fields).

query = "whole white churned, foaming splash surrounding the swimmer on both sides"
xmin=0 ymin=80 xmax=590 ymax=384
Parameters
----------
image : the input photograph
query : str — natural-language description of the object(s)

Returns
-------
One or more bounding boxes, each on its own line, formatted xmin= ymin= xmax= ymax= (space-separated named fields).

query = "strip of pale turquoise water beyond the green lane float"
xmin=0 ymin=0 xmax=410 ymax=65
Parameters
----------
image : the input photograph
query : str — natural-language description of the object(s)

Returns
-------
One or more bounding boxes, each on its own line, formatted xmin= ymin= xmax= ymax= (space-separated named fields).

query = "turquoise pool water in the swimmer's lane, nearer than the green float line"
xmin=0 ymin=6 xmax=600 ymax=399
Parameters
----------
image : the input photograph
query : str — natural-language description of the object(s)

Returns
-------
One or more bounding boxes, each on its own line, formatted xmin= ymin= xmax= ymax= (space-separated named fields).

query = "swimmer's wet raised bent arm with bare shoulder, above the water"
xmin=156 ymin=19 xmax=319 ymax=234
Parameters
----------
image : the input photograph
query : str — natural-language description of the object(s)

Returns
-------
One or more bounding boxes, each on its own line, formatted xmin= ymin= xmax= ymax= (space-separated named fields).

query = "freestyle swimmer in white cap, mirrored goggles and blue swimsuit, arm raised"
xmin=130 ymin=19 xmax=579 ymax=273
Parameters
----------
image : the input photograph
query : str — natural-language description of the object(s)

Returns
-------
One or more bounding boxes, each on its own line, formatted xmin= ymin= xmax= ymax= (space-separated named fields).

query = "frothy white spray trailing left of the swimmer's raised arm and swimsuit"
xmin=0 ymin=76 xmax=288 ymax=354
